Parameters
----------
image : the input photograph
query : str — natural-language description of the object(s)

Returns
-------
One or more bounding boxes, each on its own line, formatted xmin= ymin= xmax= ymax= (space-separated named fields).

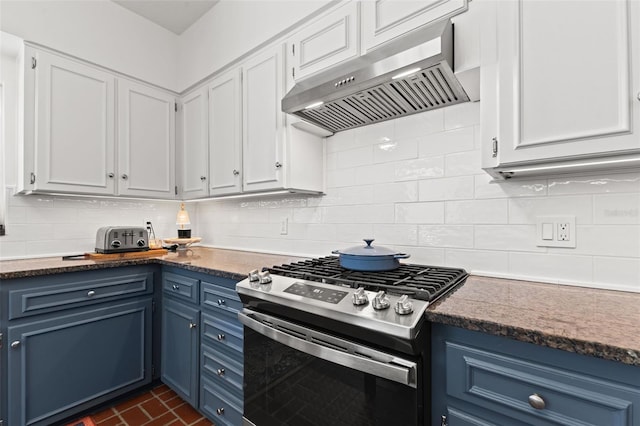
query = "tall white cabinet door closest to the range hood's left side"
xmin=242 ymin=45 xmax=287 ymax=191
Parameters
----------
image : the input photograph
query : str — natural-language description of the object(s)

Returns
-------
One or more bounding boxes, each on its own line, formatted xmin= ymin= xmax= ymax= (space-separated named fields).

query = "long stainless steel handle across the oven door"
xmin=238 ymin=308 xmax=417 ymax=388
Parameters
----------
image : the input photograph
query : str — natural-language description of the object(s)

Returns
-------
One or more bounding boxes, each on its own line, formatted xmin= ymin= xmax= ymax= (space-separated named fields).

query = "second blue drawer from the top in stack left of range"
xmin=202 ymin=312 xmax=243 ymax=357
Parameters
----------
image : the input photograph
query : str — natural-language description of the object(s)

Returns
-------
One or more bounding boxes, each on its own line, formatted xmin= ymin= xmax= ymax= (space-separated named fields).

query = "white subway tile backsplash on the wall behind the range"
xmin=197 ymin=102 xmax=640 ymax=292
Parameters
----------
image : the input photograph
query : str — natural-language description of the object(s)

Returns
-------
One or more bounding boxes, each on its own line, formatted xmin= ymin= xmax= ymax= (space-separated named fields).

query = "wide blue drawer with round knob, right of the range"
xmin=446 ymin=342 xmax=640 ymax=426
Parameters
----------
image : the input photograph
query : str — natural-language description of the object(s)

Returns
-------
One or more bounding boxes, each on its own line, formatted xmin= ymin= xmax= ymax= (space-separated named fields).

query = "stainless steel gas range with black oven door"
xmin=237 ymin=257 xmax=467 ymax=426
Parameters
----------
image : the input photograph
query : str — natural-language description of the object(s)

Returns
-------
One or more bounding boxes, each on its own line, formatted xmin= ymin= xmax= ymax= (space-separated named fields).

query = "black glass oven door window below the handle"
xmin=244 ymin=327 xmax=423 ymax=426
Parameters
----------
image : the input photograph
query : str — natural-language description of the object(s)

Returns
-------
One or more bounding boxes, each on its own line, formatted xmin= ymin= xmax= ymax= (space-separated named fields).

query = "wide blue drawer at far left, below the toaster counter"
xmin=9 ymin=272 xmax=153 ymax=320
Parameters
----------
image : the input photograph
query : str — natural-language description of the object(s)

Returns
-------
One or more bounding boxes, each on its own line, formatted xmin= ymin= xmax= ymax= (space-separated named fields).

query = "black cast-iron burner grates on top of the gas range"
xmin=265 ymin=256 xmax=468 ymax=302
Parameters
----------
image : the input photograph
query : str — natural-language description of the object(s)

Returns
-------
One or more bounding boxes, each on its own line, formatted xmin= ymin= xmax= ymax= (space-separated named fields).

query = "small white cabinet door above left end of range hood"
xmin=288 ymin=1 xmax=360 ymax=80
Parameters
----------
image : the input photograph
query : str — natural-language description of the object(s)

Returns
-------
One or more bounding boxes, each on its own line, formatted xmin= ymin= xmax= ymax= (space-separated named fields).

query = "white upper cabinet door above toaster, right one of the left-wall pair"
xmin=118 ymin=79 xmax=175 ymax=199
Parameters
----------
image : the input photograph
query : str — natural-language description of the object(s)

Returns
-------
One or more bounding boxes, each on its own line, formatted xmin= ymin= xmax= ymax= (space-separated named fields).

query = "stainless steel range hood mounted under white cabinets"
xmin=282 ymin=20 xmax=469 ymax=132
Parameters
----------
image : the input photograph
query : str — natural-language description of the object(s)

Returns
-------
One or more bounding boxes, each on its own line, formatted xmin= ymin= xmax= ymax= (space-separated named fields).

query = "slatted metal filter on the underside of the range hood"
xmin=296 ymin=64 xmax=469 ymax=133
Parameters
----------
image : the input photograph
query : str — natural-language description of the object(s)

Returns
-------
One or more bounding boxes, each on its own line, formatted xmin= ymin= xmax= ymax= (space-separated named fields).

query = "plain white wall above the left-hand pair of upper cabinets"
xmin=0 ymin=0 xmax=179 ymax=91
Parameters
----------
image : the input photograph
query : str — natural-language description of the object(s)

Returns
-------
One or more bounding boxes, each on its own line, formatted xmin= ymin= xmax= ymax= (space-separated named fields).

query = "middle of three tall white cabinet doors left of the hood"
xmin=208 ymin=69 xmax=242 ymax=196
